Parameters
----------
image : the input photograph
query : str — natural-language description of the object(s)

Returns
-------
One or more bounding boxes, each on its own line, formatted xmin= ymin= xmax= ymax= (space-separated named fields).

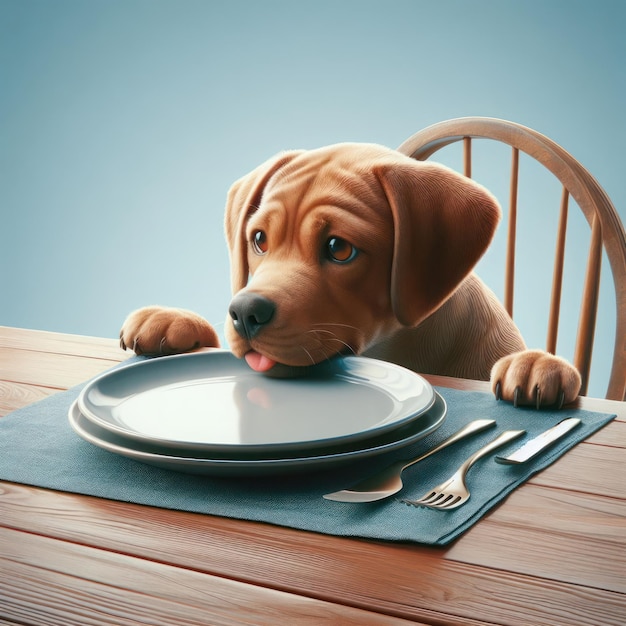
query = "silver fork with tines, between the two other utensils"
xmin=401 ymin=430 xmax=526 ymax=511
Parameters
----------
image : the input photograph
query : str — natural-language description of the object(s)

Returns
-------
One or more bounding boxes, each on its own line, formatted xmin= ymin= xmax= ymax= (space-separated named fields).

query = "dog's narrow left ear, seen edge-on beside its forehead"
xmin=224 ymin=150 xmax=302 ymax=293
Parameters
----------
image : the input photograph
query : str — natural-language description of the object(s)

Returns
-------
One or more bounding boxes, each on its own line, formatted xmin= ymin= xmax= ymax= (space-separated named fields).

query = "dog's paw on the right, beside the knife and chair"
xmin=491 ymin=350 xmax=581 ymax=409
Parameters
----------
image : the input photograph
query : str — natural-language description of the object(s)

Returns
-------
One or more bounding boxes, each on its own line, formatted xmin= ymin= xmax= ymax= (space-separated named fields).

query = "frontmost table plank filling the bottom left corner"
xmin=0 ymin=529 xmax=420 ymax=626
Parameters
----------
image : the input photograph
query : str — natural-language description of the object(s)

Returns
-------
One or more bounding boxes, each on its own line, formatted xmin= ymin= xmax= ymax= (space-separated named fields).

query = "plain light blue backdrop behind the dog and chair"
xmin=0 ymin=0 xmax=626 ymax=395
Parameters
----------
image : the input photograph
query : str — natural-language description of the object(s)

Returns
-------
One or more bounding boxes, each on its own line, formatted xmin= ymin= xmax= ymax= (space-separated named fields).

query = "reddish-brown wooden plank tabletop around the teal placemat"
xmin=0 ymin=327 xmax=626 ymax=626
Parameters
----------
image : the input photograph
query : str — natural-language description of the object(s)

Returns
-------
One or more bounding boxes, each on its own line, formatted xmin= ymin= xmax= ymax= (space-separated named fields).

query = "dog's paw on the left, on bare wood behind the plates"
xmin=120 ymin=306 xmax=220 ymax=356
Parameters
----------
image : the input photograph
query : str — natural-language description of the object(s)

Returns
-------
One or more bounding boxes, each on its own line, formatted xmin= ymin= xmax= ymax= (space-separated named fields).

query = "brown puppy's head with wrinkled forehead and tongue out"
xmin=225 ymin=144 xmax=500 ymax=371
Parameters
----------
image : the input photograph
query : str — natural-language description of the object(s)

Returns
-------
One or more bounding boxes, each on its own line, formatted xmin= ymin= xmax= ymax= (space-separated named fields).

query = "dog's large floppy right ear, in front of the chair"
xmin=375 ymin=158 xmax=500 ymax=326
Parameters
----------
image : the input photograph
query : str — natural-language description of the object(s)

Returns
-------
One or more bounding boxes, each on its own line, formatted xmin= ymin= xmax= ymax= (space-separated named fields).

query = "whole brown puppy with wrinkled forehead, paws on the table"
xmin=120 ymin=144 xmax=580 ymax=406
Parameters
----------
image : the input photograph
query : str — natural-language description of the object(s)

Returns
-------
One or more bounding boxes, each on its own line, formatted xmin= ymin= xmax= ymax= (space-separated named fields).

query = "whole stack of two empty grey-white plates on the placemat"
xmin=69 ymin=350 xmax=446 ymax=476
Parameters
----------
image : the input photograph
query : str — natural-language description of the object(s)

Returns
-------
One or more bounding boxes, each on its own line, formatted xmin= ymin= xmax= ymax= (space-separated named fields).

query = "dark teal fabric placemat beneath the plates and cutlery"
xmin=0 ymin=359 xmax=615 ymax=545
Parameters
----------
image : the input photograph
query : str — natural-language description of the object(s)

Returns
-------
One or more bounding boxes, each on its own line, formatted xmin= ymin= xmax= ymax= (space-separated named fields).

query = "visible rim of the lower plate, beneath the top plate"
xmin=69 ymin=392 xmax=447 ymax=477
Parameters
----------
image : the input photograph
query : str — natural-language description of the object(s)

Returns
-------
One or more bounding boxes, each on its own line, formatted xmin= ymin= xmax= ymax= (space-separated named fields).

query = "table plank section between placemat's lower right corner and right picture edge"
xmin=446 ymin=485 xmax=626 ymax=588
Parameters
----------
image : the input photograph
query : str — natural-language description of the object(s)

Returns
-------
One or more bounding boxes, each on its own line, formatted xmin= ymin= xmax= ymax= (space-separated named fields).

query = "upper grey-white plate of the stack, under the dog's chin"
xmin=78 ymin=350 xmax=435 ymax=457
